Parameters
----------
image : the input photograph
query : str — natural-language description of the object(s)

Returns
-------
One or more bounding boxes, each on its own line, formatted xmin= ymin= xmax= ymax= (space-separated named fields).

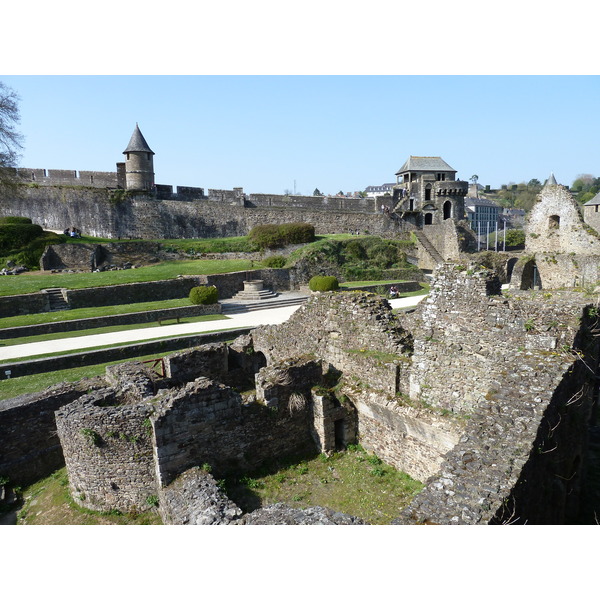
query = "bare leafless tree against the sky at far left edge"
xmin=0 ymin=81 xmax=23 ymax=195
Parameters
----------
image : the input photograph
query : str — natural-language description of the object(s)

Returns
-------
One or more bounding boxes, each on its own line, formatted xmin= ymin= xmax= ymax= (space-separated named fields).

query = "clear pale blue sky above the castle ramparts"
xmin=0 ymin=75 xmax=600 ymax=194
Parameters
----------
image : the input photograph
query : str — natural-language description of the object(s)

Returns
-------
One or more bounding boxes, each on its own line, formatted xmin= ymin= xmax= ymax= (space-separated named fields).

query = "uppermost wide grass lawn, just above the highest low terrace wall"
xmin=0 ymin=259 xmax=255 ymax=296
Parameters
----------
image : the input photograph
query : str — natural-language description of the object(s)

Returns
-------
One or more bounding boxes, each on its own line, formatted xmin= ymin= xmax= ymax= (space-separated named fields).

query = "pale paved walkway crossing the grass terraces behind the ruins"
xmin=0 ymin=294 xmax=425 ymax=361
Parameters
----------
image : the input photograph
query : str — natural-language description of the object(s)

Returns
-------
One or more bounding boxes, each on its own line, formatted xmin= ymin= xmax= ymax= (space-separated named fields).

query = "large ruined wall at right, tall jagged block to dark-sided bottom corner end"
xmin=396 ymin=265 xmax=598 ymax=524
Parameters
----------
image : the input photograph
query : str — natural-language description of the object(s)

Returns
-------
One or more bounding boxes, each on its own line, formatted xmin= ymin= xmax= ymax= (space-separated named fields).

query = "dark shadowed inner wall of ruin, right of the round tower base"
xmin=151 ymin=378 xmax=314 ymax=486
